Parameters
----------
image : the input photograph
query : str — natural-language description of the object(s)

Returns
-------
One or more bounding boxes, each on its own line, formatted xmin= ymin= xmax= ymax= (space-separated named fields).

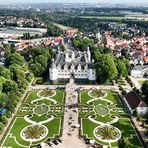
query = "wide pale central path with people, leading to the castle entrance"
xmin=54 ymin=80 xmax=88 ymax=148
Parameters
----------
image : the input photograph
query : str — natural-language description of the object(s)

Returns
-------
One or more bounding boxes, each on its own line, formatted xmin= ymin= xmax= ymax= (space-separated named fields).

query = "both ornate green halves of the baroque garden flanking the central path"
xmin=2 ymin=89 xmax=142 ymax=148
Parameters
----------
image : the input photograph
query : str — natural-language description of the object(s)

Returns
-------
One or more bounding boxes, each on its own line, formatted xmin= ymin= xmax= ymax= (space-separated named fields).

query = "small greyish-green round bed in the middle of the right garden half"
xmin=94 ymin=104 xmax=109 ymax=116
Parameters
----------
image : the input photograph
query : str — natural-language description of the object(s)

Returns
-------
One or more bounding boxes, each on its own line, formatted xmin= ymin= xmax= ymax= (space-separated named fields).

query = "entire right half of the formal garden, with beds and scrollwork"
xmin=79 ymin=90 xmax=142 ymax=148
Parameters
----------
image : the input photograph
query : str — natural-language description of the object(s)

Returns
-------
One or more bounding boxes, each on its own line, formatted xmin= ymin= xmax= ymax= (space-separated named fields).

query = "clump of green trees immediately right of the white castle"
xmin=93 ymin=47 xmax=130 ymax=83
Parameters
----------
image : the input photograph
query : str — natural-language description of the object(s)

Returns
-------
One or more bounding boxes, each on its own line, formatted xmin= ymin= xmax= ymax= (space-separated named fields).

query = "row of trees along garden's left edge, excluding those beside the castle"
xmin=0 ymin=46 xmax=33 ymax=132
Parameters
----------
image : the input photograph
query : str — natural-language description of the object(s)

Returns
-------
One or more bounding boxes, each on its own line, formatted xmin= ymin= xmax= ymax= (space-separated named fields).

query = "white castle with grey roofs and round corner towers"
xmin=49 ymin=48 xmax=96 ymax=83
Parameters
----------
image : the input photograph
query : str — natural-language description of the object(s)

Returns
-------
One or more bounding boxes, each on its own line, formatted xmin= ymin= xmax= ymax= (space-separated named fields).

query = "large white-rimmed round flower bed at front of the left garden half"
xmin=20 ymin=124 xmax=48 ymax=142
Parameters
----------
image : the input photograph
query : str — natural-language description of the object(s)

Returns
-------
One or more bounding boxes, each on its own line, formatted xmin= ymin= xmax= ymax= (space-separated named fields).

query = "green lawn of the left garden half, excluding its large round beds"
xmin=2 ymin=90 xmax=65 ymax=148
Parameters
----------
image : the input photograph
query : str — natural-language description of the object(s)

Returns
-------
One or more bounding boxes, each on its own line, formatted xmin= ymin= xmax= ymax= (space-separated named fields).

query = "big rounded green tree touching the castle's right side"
xmin=96 ymin=54 xmax=117 ymax=82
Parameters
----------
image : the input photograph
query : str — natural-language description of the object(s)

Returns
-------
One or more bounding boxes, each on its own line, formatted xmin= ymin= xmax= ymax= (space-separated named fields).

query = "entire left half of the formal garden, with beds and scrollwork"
xmin=2 ymin=89 xmax=65 ymax=148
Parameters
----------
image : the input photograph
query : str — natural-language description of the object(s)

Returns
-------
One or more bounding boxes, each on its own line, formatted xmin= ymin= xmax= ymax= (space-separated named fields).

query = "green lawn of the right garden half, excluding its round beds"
xmin=79 ymin=90 xmax=142 ymax=148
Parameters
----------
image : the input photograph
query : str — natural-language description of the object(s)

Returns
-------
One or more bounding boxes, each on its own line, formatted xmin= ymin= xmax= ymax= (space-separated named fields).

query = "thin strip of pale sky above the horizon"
xmin=0 ymin=0 xmax=148 ymax=4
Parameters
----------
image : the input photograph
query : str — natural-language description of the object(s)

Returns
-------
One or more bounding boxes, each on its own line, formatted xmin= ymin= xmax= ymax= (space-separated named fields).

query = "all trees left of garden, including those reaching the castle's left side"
xmin=0 ymin=45 xmax=53 ymax=132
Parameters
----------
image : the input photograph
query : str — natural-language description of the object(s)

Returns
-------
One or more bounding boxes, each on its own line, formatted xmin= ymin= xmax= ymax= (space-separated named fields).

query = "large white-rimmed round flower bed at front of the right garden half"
xmin=94 ymin=125 xmax=121 ymax=143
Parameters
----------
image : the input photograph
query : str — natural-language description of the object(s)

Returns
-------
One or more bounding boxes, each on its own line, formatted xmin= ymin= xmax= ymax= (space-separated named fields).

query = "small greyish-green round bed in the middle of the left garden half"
xmin=34 ymin=104 xmax=49 ymax=115
